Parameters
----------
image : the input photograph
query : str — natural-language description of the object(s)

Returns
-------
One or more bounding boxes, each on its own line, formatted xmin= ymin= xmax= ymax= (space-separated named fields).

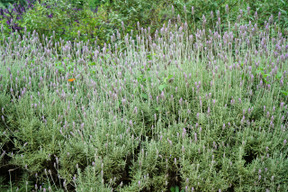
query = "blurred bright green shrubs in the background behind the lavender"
xmin=0 ymin=0 xmax=288 ymax=53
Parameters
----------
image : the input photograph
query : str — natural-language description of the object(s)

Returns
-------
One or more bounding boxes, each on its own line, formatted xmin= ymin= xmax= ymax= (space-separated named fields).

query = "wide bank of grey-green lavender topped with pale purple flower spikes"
xmin=0 ymin=3 xmax=288 ymax=191
